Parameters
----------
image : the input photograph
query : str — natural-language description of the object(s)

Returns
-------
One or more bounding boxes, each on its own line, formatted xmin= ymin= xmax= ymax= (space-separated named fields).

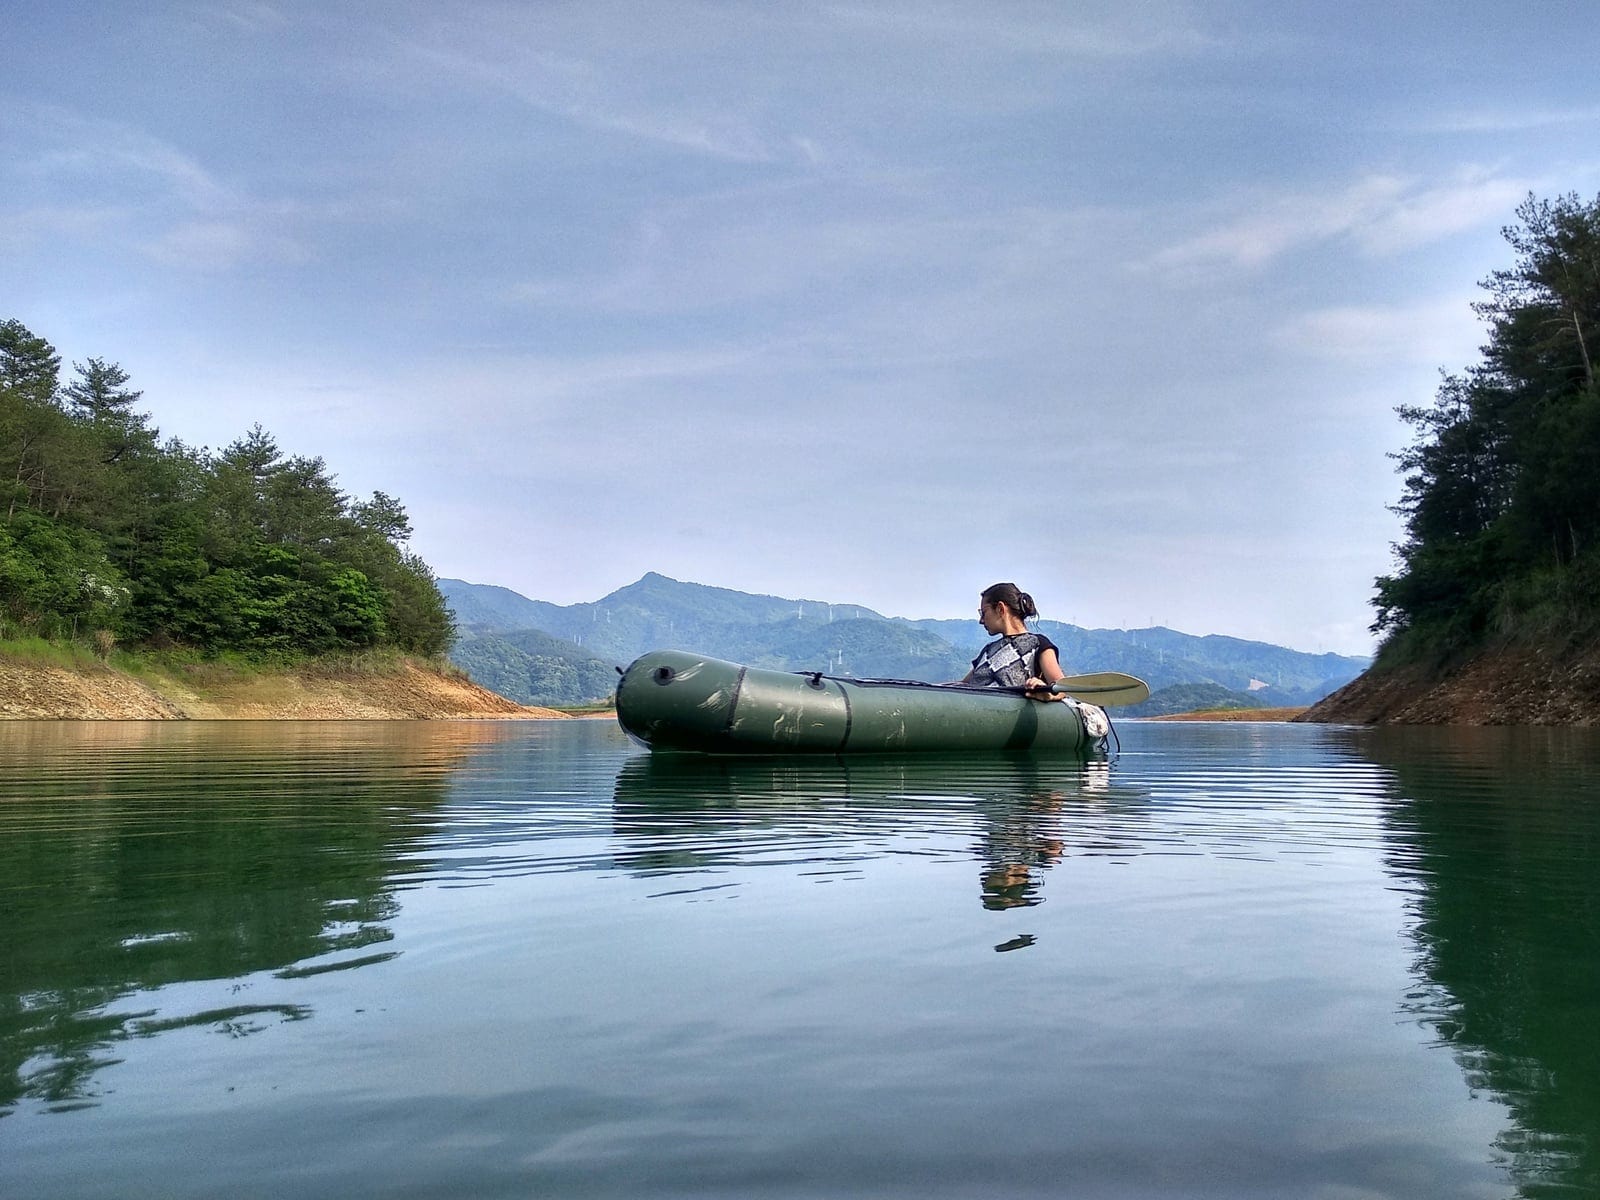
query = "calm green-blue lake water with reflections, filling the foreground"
xmin=0 ymin=722 xmax=1600 ymax=1200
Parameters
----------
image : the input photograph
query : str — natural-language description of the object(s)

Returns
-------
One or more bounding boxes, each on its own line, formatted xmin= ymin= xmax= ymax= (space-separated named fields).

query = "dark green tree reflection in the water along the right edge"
xmin=1346 ymin=728 xmax=1600 ymax=1197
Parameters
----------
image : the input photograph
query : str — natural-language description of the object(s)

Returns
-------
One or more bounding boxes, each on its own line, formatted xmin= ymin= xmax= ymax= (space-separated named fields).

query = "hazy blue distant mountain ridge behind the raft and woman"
xmin=438 ymin=571 xmax=1368 ymax=712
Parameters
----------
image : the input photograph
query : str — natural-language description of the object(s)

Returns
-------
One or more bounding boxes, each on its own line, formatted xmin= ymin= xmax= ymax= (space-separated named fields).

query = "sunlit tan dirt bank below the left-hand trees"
xmin=0 ymin=658 xmax=565 ymax=720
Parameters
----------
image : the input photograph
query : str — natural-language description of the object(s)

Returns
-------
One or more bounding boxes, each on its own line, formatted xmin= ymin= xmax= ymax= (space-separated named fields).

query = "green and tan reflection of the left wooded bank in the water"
xmin=0 ymin=722 xmax=499 ymax=1115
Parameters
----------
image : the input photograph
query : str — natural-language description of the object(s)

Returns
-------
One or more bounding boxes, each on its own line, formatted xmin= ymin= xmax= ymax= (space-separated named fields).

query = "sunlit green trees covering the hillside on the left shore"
xmin=0 ymin=320 xmax=453 ymax=654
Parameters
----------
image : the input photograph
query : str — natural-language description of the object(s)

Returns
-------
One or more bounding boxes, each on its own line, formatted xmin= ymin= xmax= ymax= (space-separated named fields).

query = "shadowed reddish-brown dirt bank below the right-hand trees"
xmin=1296 ymin=645 xmax=1600 ymax=725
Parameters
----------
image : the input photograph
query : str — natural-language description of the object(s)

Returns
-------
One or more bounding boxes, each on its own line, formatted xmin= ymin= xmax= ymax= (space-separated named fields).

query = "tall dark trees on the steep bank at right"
xmin=1373 ymin=195 xmax=1600 ymax=662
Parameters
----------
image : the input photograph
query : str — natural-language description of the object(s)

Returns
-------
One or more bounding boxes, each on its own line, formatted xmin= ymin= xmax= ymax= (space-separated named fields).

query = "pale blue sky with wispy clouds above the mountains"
xmin=0 ymin=0 xmax=1600 ymax=654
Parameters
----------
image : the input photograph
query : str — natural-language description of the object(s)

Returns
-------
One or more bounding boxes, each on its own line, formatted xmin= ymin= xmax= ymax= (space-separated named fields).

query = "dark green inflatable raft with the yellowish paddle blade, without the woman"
xmin=604 ymin=650 xmax=1149 ymax=754
